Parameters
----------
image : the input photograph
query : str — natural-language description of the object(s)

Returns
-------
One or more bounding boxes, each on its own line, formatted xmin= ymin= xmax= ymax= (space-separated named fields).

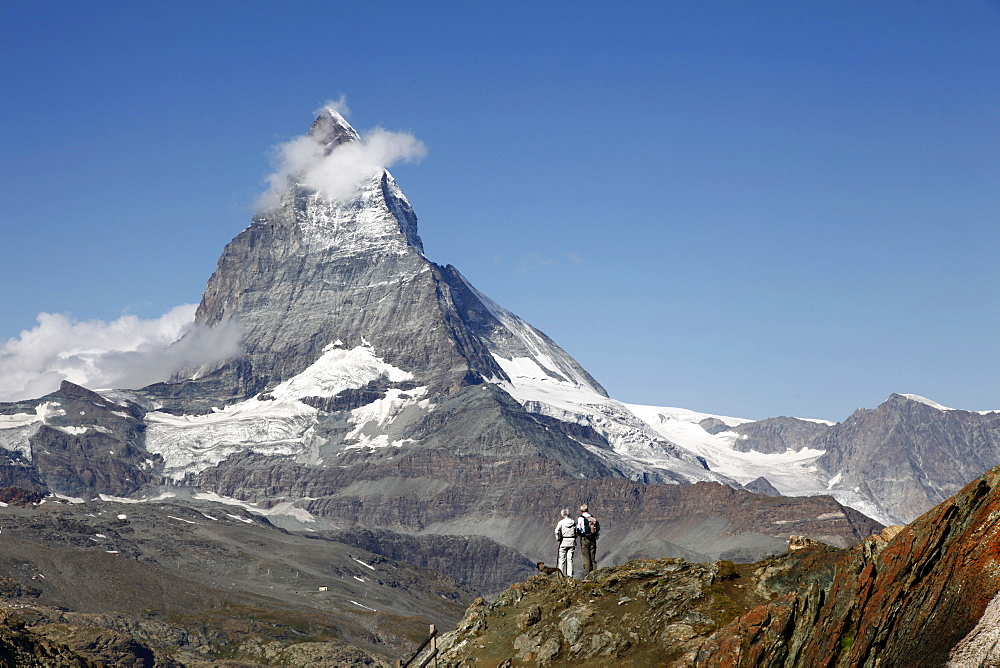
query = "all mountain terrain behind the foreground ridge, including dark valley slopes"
xmin=0 ymin=109 xmax=1000 ymax=665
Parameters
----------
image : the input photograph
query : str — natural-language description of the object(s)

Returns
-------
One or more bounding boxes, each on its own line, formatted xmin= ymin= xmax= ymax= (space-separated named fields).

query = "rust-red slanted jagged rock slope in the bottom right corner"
xmin=697 ymin=469 xmax=1000 ymax=666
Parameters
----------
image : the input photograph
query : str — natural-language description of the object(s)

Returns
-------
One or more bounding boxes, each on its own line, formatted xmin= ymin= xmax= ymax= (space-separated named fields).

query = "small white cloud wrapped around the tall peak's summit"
xmin=257 ymin=97 xmax=427 ymax=211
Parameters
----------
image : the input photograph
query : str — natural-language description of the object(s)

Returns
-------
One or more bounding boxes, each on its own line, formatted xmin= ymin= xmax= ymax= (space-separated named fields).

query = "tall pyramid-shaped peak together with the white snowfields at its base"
xmin=137 ymin=110 xmax=732 ymax=483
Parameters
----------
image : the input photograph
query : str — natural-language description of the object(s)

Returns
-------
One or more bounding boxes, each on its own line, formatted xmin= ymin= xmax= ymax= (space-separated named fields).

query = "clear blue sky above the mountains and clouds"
xmin=0 ymin=0 xmax=1000 ymax=420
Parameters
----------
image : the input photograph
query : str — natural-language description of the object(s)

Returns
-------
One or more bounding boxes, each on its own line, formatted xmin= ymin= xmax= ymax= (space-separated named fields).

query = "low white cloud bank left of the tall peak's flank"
xmin=0 ymin=304 xmax=242 ymax=401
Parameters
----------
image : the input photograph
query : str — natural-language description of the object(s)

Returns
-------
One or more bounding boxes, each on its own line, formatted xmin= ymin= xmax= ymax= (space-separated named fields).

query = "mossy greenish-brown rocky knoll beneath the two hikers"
xmin=439 ymin=559 xmax=748 ymax=667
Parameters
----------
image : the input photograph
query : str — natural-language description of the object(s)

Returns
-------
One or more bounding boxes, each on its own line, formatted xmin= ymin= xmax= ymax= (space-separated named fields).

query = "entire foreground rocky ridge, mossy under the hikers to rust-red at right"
xmin=441 ymin=468 xmax=1000 ymax=667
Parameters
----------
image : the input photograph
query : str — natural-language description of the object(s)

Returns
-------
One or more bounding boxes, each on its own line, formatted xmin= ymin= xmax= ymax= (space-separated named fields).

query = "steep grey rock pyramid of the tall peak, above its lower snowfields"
xmin=177 ymin=110 xmax=588 ymax=408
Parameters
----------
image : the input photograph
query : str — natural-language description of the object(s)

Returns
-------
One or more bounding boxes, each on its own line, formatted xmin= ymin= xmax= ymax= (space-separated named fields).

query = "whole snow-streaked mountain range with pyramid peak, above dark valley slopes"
xmin=0 ymin=110 xmax=988 ymax=580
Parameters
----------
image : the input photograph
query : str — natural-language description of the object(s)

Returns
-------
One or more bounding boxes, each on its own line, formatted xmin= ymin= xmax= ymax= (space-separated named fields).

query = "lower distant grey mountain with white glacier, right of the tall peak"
xmin=628 ymin=394 xmax=1000 ymax=525
